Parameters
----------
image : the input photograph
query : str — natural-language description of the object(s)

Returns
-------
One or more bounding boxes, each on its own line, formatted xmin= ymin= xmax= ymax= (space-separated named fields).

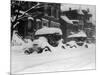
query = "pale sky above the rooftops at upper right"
xmin=61 ymin=3 xmax=96 ymax=24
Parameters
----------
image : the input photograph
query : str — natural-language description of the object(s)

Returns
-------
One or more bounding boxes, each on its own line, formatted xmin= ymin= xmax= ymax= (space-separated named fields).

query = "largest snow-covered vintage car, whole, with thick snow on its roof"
xmin=25 ymin=27 xmax=62 ymax=53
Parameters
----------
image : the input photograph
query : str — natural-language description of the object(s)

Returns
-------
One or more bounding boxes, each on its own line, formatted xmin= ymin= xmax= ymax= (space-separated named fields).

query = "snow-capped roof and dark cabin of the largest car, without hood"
xmin=35 ymin=27 xmax=62 ymax=47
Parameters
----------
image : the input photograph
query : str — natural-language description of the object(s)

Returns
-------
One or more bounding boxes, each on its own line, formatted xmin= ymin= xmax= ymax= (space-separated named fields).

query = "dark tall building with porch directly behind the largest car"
xmin=25 ymin=3 xmax=60 ymax=38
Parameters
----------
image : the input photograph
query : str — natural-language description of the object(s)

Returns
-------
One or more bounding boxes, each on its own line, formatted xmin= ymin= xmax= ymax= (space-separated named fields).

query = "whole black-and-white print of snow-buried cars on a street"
xmin=10 ymin=0 xmax=96 ymax=75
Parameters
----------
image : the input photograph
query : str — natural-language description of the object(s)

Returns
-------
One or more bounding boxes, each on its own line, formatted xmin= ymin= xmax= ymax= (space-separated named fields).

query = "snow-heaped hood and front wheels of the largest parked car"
xmin=24 ymin=37 xmax=51 ymax=54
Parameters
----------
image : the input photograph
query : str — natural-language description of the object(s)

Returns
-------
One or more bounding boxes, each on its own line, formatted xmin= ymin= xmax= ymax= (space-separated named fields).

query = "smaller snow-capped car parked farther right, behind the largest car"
xmin=66 ymin=31 xmax=88 ymax=48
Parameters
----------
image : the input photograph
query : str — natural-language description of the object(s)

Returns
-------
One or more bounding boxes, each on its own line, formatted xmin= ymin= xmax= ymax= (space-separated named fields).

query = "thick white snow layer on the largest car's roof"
xmin=35 ymin=27 xmax=62 ymax=35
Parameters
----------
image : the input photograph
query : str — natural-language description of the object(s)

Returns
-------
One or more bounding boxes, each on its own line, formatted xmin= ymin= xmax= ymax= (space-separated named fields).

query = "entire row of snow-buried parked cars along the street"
xmin=24 ymin=27 xmax=88 ymax=54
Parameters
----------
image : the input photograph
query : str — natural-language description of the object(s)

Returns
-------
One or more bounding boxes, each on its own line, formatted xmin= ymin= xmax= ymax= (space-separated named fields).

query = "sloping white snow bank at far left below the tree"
xmin=11 ymin=31 xmax=32 ymax=50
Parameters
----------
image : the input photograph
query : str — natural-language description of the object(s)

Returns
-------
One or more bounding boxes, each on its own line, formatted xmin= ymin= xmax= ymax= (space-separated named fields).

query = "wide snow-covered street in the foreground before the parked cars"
xmin=11 ymin=46 xmax=95 ymax=74
